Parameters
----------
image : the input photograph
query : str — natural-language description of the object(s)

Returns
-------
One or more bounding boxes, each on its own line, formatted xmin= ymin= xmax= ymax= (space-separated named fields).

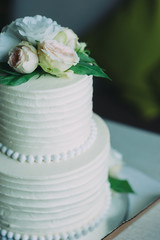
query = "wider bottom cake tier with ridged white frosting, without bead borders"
xmin=0 ymin=116 xmax=110 ymax=235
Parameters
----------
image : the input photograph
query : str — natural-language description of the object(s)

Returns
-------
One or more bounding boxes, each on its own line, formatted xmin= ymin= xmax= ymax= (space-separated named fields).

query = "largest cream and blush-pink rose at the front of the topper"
xmin=38 ymin=40 xmax=79 ymax=76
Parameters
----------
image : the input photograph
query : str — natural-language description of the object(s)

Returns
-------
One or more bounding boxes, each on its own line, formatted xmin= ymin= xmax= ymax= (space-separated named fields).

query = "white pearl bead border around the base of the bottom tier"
xmin=0 ymin=186 xmax=111 ymax=240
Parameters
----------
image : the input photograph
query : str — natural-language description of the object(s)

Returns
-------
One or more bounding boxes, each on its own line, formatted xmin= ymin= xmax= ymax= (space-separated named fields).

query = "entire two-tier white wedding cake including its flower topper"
xmin=0 ymin=16 xmax=131 ymax=240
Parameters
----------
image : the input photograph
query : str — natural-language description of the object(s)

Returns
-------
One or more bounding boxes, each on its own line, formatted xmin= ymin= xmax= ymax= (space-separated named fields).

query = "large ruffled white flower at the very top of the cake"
xmin=2 ymin=15 xmax=63 ymax=45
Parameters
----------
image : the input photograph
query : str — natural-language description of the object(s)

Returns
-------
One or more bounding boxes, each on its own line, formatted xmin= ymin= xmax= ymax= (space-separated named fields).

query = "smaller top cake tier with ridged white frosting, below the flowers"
xmin=0 ymin=74 xmax=92 ymax=155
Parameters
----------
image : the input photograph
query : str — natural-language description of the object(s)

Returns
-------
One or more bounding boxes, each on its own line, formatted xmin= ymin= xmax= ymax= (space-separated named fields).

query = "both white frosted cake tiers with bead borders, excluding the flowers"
xmin=0 ymin=75 xmax=110 ymax=239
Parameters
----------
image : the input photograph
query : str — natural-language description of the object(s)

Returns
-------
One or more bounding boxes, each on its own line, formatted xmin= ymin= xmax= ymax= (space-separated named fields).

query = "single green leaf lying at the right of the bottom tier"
xmin=108 ymin=177 xmax=134 ymax=193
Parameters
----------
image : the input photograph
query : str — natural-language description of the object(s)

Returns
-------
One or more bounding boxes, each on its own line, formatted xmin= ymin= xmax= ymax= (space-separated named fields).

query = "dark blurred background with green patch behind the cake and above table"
xmin=0 ymin=0 xmax=160 ymax=133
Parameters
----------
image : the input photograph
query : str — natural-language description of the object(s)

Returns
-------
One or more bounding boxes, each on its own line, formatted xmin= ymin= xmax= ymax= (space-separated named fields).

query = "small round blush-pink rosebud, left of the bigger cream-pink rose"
xmin=8 ymin=41 xmax=38 ymax=73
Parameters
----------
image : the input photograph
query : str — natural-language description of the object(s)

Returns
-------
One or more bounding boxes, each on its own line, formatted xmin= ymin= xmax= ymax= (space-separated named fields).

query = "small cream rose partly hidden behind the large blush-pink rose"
xmin=54 ymin=28 xmax=78 ymax=49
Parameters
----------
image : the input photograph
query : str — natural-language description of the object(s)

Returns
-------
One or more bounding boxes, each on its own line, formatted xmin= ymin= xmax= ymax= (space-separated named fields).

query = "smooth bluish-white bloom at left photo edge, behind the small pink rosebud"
xmin=0 ymin=32 xmax=20 ymax=62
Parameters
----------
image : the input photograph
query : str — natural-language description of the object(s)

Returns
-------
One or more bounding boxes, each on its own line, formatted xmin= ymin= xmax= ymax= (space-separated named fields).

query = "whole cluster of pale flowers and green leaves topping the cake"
xmin=0 ymin=15 xmax=109 ymax=86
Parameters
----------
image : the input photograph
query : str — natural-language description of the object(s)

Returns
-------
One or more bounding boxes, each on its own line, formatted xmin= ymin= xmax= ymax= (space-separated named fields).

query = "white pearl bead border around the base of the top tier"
xmin=0 ymin=120 xmax=97 ymax=164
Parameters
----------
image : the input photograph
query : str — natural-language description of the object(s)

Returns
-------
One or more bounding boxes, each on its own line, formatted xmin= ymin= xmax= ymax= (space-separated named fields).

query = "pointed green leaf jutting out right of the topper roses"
xmin=70 ymin=61 xmax=111 ymax=80
